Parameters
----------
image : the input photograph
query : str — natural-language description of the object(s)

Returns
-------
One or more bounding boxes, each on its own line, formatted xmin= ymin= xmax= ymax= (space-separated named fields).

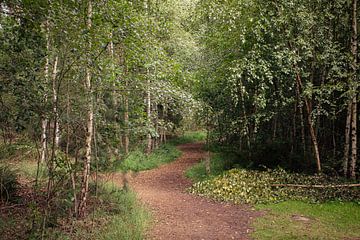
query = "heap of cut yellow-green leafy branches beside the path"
xmin=190 ymin=169 xmax=360 ymax=203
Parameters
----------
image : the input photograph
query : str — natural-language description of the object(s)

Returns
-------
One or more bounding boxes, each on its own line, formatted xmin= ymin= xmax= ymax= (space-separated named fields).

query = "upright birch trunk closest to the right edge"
xmin=350 ymin=0 xmax=358 ymax=179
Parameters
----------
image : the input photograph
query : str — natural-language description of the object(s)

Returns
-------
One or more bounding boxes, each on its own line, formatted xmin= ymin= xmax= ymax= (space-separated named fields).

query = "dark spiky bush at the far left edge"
xmin=0 ymin=165 xmax=19 ymax=202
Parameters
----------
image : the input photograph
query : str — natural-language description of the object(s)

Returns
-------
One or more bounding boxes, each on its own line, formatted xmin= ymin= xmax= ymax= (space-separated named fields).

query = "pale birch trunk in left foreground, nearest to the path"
xmin=78 ymin=0 xmax=94 ymax=217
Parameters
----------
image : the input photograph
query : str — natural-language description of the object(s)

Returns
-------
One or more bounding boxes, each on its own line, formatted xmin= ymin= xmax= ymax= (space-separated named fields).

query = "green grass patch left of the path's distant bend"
xmin=116 ymin=144 xmax=181 ymax=172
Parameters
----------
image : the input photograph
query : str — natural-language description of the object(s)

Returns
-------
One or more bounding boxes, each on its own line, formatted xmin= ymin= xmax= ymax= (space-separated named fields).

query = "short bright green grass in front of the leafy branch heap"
xmin=252 ymin=201 xmax=360 ymax=240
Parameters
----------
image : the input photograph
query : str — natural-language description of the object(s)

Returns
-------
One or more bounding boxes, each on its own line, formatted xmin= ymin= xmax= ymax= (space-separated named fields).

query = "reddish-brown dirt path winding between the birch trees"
xmin=115 ymin=143 xmax=262 ymax=239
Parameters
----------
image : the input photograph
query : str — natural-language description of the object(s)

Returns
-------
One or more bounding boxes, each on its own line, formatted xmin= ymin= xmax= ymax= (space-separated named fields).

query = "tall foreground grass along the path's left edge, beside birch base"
xmin=69 ymin=182 xmax=150 ymax=240
